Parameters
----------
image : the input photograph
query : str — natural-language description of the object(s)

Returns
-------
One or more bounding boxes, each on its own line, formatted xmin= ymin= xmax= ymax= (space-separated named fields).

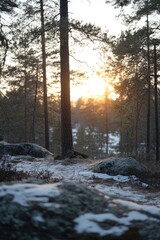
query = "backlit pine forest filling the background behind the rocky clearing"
xmin=0 ymin=0 xmax=160 ymax=161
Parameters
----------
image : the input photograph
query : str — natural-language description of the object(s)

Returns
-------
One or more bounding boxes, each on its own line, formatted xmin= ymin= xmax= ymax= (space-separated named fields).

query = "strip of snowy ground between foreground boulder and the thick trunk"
xmin=15 ymin=160 xmax=160 ymax=207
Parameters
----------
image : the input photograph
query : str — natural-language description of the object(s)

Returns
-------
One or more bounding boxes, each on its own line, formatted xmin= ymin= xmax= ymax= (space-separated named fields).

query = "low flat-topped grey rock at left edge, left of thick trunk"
xmin=0 ymin=142 xmax=53 ymax=158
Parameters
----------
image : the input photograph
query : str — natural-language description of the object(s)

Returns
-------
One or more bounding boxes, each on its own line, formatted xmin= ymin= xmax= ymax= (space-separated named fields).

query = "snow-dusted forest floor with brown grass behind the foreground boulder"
xmin=5 ymin=159 xmax=160 ymax=208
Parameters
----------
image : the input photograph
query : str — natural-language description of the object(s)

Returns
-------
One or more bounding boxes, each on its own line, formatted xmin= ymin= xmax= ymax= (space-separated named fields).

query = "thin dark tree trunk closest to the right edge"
xmin=154 ymin=43 xmax=159 ymax=161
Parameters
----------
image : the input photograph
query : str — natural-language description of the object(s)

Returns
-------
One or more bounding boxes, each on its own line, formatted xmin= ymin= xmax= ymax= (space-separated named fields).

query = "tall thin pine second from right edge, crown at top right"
xmin=106 ymin=0 xmax=160 ymax=159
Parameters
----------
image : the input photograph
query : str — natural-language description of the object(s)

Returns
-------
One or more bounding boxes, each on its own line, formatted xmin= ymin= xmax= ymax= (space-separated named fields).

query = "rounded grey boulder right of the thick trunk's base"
xmin=92 ymin=157 xmax=150 ymax=177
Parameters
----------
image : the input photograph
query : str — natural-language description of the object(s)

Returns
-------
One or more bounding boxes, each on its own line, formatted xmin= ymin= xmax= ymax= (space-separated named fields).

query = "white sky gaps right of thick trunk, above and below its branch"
xmin=69 ymin=0 xmax=122 ymax=100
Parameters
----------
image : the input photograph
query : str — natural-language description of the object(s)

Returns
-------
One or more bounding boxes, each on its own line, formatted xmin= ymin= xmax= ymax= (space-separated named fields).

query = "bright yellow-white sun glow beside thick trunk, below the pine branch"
xmin=70 ymin=35 xmax=117 ymax=101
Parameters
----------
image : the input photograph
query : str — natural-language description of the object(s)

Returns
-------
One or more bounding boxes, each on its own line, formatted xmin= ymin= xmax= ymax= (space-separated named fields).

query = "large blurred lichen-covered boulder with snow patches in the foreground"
xmin=0 ymin=183 xmax=160 ymax=240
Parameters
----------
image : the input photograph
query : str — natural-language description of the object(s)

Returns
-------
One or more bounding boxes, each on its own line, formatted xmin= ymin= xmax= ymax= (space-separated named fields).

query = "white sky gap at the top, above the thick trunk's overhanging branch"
xmin=69 ymin=0 xmax=122 ymax=35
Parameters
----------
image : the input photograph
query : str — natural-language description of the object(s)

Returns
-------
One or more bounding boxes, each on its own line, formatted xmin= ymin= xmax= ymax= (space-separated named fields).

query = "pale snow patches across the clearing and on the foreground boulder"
xmin=0 ymin=157 xmax=160 ymax=240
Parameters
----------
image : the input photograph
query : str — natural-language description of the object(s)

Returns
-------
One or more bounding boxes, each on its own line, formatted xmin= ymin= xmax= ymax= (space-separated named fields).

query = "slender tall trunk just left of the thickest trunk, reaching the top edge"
xmin=40 ymin=0 xmax=49 ymax=150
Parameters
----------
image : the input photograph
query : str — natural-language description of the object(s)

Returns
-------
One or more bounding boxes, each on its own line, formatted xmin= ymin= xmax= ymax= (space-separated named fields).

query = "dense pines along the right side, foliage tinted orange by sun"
xmin=106 ymin=0 xmax=160 ymax=160
